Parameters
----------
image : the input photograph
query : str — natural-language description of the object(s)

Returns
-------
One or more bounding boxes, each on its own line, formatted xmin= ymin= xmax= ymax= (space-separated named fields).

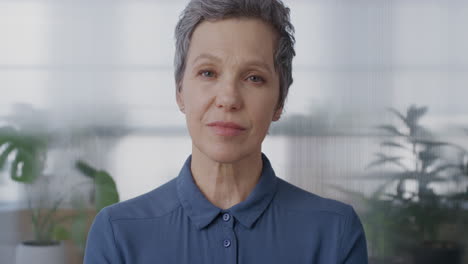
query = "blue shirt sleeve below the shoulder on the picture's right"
xmin=340 ymin=207 xmax=368 ymax=264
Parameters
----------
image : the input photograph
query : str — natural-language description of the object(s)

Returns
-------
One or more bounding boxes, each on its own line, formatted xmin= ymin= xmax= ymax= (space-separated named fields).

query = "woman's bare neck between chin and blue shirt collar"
xmin=191 ymin=146 xmax=263 ymax=209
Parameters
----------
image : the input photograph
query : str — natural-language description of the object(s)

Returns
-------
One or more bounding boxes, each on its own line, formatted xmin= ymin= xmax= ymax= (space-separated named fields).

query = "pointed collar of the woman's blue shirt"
xmin=177 ymin=153 xmax=277 ymax=229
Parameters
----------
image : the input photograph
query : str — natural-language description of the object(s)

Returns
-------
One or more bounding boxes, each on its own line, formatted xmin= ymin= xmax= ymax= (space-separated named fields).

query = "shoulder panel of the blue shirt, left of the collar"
xmin=100 ymin=178 xmax=180 ymax=221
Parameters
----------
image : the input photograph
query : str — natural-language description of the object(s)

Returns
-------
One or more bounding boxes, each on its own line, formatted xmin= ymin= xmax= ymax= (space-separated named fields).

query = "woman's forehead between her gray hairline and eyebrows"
xmin=187 ymin=18 xmax=277 ymax=66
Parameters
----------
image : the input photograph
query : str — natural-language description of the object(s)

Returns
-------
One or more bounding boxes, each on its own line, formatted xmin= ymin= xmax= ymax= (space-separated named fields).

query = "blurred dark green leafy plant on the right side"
xmin=332 ymin=106 xmax=468 ymax=263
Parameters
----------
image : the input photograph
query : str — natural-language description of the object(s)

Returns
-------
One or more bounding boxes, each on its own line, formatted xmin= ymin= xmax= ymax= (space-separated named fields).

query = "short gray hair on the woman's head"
xmin=174 ymin=0 xmax=296 ymax=108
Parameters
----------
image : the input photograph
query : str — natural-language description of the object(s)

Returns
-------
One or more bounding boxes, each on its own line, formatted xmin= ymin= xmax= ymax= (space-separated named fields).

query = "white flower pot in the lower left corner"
xmin=15 ymin=241 xmax=66 ymax=264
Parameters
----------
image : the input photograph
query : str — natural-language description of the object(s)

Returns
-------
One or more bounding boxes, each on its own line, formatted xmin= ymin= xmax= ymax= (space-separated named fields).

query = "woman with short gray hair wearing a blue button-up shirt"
xmin=85 ymin=0 xmax=367 ymax=264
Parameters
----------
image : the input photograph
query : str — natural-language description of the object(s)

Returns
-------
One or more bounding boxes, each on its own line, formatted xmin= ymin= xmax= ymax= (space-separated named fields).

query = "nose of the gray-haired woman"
xmin=216 ymin=79 xmax=242 ymax=111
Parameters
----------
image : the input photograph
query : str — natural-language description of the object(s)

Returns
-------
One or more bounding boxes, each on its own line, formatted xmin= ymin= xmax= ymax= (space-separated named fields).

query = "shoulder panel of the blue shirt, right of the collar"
xmin=275 ymin=178 xmax=354 ymax=219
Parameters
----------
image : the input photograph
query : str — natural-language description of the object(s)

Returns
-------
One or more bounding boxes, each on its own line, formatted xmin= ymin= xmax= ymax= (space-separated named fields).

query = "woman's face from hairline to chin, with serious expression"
xmin=177 ymin=19 xmax=282 ymax=163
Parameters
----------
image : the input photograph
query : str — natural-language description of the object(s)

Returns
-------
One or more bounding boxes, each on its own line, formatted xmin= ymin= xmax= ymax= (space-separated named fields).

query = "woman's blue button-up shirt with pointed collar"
xmin=84 ymin=154 xmax=367 ymax=264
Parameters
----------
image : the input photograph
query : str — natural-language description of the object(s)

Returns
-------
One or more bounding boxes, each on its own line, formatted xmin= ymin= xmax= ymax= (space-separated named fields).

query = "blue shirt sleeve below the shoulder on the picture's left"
xmin=84 ymin=207 xmax=123 ymax=264
